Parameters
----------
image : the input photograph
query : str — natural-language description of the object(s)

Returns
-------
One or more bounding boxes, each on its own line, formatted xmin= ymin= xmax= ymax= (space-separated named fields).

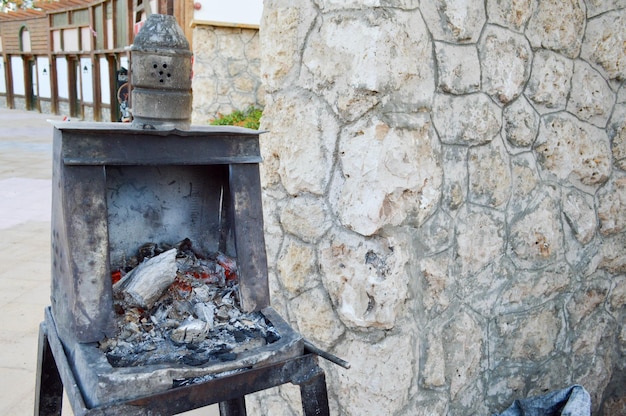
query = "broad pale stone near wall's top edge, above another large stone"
xmin=301 ymin=9 xmax=434 ymax=120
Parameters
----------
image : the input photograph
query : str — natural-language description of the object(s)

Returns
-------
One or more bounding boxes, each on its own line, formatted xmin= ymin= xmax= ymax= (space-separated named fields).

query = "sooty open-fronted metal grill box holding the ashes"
xmin=52 ymin=123 xmax=303 ymax=406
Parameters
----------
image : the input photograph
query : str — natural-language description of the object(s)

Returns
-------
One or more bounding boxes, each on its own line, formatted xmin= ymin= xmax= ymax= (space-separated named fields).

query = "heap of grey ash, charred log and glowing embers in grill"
xmin=99 ymin=239 xmax=280 ymax=367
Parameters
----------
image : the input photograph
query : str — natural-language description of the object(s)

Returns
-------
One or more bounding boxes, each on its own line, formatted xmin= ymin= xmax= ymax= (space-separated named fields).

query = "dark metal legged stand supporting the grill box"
xmin=35 ymin=308 xmax=330 ymax=416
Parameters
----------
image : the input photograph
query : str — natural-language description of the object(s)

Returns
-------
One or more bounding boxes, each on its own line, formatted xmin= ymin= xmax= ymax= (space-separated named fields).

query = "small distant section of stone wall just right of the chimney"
xmin=192 ymin=25 xmax=265 ymax=125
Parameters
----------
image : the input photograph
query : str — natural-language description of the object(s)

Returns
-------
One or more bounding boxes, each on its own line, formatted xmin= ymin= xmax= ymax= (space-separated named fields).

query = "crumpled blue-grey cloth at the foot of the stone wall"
xmin=493 ymin=385 xmax=591 ymax=416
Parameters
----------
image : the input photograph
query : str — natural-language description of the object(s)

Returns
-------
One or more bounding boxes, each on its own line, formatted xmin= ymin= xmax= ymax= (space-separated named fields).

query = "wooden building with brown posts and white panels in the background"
xmin=0 ymin=0 xmax=193 ymax=121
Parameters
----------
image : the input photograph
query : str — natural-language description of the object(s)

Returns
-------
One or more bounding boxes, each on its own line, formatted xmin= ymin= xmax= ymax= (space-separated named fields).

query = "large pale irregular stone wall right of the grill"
xmin=251 ymin=0 xmax=626 ymax=416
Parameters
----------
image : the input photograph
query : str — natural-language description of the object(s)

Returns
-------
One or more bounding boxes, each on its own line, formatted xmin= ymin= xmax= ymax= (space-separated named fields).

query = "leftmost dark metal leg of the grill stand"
xmin=35 ymin=323 xmax=63 ymax=416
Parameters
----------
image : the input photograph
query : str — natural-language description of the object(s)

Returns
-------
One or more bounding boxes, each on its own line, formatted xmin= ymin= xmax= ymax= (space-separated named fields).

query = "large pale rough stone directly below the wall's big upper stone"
xmin=335 ymin=118 xmax=441 ymax=235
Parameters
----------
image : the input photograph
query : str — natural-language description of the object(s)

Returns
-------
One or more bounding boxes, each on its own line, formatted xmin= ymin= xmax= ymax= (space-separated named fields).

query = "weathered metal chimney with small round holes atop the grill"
xmin=130 ymin=14 xmax=192 ymax=130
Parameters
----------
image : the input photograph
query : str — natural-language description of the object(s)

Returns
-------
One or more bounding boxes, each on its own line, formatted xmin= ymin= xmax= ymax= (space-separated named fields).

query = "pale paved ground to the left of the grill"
xmin=0 ymin=108 xmax=219 ymax=416
